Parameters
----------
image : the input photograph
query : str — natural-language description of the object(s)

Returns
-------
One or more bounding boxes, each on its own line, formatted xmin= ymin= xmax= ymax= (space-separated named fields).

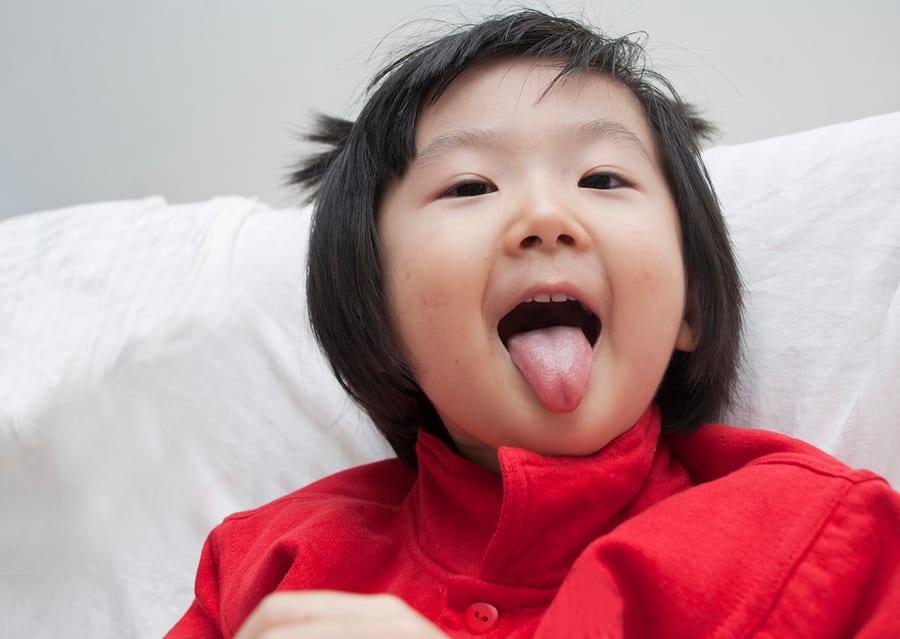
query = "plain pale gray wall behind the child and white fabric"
xmin=0 ymin=0 xmax=900 ymax=218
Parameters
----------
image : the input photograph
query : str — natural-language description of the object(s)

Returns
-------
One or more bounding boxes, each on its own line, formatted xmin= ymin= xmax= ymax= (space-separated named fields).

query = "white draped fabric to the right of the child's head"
xmin=706 ymin=113 xmax=900 ymax=487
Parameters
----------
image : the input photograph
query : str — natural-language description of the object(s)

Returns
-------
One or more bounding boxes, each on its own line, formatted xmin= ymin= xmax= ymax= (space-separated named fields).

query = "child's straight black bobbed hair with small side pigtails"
xmin=291 ymin=10 xmax=741 ymax=464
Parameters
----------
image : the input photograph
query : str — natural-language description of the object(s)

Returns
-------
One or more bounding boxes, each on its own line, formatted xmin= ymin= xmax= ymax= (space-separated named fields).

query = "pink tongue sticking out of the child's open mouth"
xmin=507 ymin=326 xmax=592 ymax=413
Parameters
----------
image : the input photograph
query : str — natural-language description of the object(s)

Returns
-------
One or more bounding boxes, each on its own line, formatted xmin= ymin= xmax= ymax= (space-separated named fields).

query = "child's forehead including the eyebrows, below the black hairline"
xmin=415 ymin=58 xmax=656 ymax=161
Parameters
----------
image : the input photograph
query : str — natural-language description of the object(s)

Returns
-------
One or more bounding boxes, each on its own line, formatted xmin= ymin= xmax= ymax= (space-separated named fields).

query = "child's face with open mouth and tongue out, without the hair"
xmin=378 ymin=60 xmax=694 ymax=469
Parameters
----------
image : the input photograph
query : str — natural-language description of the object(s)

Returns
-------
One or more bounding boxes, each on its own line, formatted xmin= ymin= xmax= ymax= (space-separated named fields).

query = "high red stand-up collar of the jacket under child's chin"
xmin=410 ymin=406 xmax=690 ymax=588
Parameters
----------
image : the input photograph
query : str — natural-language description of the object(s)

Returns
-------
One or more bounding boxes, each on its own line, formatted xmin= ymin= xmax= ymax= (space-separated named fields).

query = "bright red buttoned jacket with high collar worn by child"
xmin=167 ymin=409 xmax=900 ymax=639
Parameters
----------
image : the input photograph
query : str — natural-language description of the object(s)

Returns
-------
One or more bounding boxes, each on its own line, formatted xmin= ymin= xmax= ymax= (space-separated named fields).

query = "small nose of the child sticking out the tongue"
xmin=505 ymin=190 xmax=589 ymax=254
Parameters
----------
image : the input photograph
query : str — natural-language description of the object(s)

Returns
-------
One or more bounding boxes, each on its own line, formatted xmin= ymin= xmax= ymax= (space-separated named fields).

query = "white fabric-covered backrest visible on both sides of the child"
xmin=0 ymin=114 xmax=900 ymax=638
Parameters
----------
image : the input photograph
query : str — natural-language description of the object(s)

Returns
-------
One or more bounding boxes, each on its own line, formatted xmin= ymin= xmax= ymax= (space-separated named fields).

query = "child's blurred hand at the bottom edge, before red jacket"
xmin=235 ymin=590 xmax=446 ymax=639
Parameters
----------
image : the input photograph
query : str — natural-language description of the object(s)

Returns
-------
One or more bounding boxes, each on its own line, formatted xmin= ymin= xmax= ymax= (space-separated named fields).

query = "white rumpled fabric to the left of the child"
xmin=0 ymin=198 xmax=389 ymax=639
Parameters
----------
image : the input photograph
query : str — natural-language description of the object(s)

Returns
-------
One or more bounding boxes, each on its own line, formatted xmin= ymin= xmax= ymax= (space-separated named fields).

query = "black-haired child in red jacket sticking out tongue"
xmin=168 ymin=11 xmax=900 ymax=639
